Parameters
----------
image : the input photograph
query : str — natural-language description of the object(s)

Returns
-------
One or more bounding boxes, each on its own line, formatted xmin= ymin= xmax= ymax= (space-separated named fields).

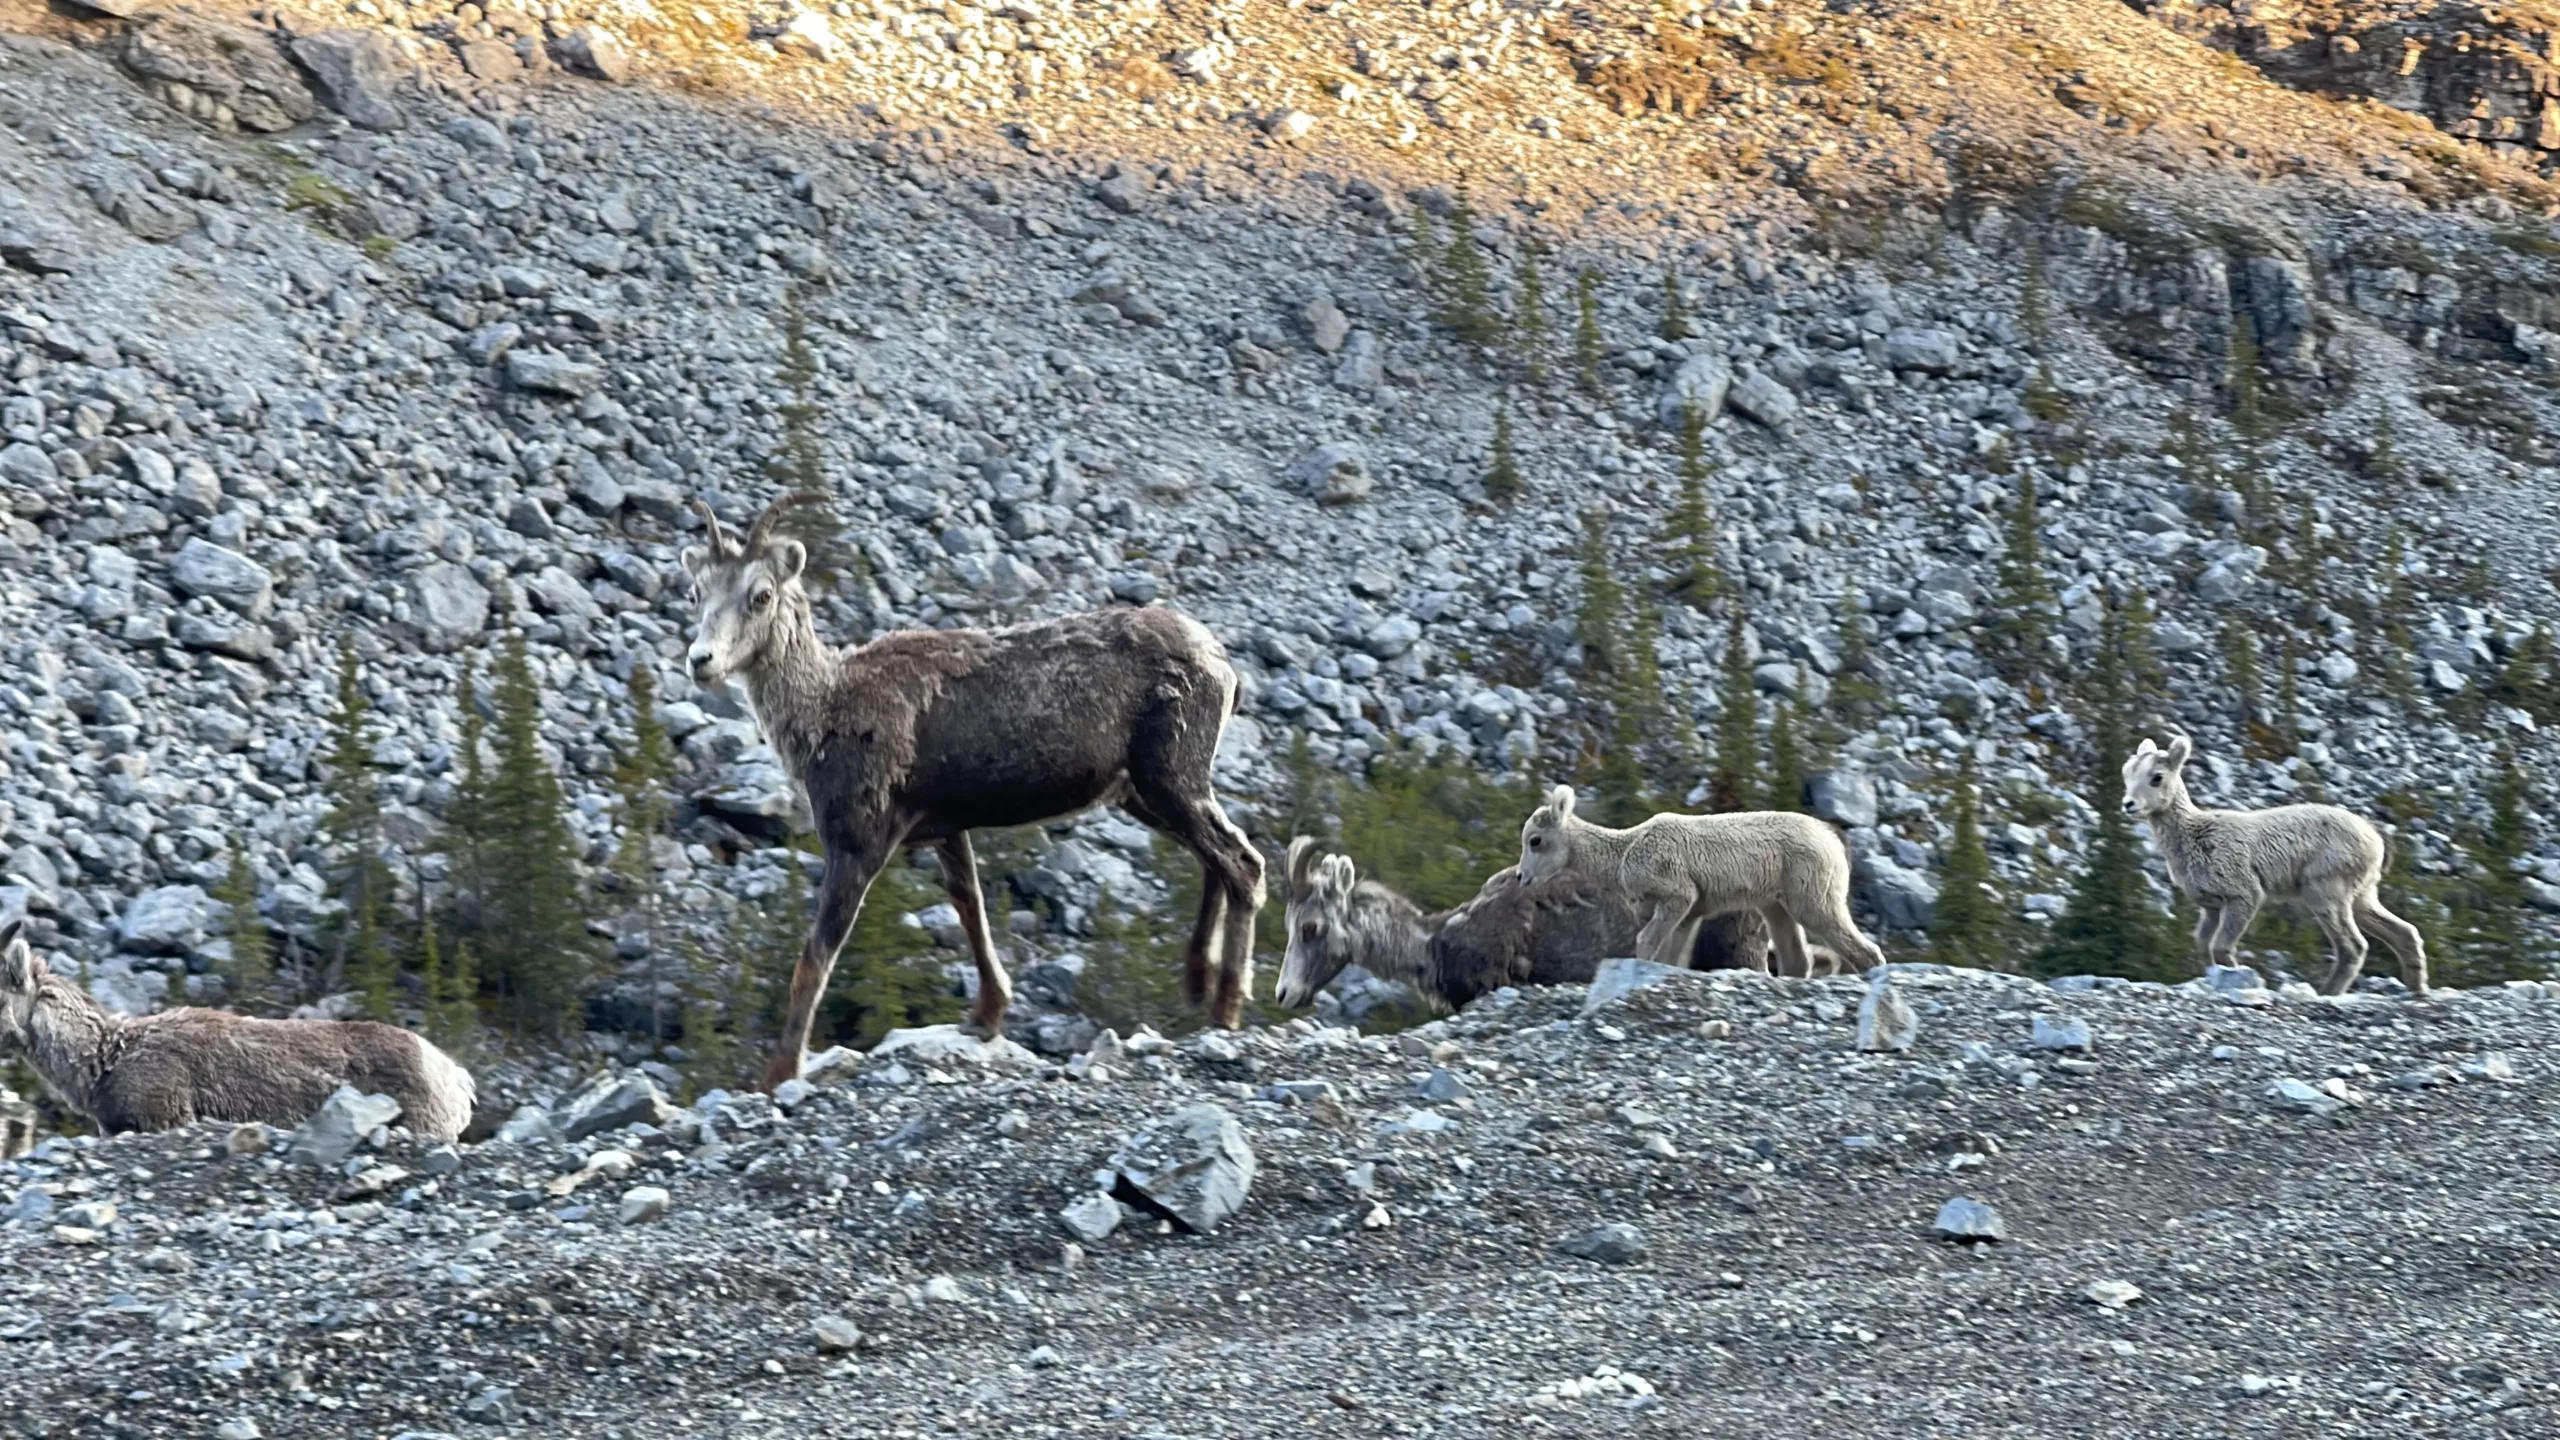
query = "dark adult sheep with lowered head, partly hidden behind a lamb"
xmin=1272 ymin=835 xmax=1802 ymax=1010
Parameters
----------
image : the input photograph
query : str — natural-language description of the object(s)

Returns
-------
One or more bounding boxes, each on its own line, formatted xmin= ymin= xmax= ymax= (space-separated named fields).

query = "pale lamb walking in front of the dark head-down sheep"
xmin=1521 ymin=784 xmax=1884 ymax=974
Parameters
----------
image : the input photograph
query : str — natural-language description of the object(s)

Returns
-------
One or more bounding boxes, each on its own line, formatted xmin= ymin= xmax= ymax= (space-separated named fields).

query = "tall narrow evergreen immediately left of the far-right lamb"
xmin=2035 ymin=599 xmax=2181 ymax=979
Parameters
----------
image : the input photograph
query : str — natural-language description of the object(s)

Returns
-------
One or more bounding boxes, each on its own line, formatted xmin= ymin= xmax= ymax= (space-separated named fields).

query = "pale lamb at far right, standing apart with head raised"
xmin=2125 ymin=735 xmax=2427 ymax=994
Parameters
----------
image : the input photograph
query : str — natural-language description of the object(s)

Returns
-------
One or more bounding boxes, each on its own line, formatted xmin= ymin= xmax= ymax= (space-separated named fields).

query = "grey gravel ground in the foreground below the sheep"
xmin=0 ymin=961 xmax=2560 ymax=1440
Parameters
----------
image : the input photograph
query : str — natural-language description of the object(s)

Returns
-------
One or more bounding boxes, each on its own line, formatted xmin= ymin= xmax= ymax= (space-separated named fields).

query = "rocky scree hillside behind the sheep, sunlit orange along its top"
xmin=0 ymin=3 xmax=2560 ymax=1030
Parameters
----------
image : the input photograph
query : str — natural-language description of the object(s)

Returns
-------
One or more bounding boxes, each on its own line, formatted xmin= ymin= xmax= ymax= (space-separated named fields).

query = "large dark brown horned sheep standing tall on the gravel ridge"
xmin=681 ymin=492 xmax=1262 ymax=1089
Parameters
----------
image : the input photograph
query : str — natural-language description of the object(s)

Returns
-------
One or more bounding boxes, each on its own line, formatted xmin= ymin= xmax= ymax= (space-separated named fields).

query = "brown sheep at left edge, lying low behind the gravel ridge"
xmin=0 ymin=912 xmax=474 ymax=1140
